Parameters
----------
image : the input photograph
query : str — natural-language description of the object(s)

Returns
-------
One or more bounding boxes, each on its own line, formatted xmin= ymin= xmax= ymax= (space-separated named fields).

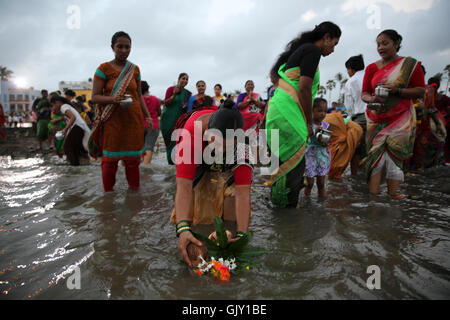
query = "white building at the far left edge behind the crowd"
xmin=0 ymin=80 xmax=41 ymax=113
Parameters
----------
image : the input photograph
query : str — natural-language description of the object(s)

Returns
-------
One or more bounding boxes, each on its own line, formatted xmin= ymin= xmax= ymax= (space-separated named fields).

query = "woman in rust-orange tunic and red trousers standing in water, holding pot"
xmin=92 ymin=32 xmax=153 ymax=192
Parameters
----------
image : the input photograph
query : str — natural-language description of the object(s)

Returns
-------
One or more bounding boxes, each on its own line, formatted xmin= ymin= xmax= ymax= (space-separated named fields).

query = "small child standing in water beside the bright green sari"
xmin=305 ymin=98 xmax=331 ymax=197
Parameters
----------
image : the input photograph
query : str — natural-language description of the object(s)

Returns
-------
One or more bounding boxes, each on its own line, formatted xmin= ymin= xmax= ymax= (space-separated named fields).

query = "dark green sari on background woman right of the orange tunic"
xmin=160 ymin=87 xmax=192 ymax=165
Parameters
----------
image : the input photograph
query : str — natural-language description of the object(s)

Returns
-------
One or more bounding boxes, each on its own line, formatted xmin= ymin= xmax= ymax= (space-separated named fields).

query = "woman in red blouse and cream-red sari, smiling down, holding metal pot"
xmin=362 ymin=30 xmax=425 ymax=199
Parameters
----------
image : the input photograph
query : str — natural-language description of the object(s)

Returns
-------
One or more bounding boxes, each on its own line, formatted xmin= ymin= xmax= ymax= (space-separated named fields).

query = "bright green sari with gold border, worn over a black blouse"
xmin=266 ymin=64 xmax=320 ymax=208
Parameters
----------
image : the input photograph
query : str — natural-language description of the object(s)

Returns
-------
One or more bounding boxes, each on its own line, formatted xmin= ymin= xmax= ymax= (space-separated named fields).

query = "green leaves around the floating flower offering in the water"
xmin=193 ymin=217 xmax=267 ymax=271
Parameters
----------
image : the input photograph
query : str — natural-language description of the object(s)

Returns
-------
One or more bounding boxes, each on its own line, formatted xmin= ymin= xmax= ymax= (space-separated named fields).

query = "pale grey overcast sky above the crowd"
xmin=0 ymin=0 xmax=450 ymax=99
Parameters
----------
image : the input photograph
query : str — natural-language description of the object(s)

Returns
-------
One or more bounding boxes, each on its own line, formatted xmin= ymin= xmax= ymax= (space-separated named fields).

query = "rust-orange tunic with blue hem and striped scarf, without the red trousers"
xmin=88 ymin=61 xmax=144 ymax=161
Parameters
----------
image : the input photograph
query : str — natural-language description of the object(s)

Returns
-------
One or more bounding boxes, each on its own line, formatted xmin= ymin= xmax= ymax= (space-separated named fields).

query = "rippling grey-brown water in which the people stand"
xmin=0 ymin=155 xmax=450 ymax=299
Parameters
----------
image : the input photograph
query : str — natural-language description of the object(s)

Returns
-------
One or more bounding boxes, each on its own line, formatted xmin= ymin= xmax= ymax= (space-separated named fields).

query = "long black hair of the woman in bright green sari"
xmin=271 ymin=21 xmax=342 ymax=77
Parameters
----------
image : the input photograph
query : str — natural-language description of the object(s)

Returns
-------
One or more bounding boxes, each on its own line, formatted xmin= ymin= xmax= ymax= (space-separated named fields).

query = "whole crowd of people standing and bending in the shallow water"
xmin=2 ymin=22 xmax=450 ymax=264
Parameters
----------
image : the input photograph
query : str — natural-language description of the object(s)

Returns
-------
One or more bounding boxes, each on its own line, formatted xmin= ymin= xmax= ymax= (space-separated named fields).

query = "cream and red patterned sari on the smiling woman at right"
xmin=365 ymin=57 xmax=423 ymax=180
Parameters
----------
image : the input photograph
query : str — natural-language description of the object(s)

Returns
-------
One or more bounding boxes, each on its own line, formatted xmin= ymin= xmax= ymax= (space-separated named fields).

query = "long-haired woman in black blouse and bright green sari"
xmin=266 ymin=22 xmax=341 ymax=208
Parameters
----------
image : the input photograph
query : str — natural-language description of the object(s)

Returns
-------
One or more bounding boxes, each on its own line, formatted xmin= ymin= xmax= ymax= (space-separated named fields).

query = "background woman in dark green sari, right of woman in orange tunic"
xmin=160 ymin=73 xmax=192 ymax=165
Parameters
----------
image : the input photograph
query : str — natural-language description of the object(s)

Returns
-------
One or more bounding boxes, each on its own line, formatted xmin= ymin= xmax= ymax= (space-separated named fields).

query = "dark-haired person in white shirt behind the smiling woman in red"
xmin=344 ymin=55 xmax=367 ymax=175
